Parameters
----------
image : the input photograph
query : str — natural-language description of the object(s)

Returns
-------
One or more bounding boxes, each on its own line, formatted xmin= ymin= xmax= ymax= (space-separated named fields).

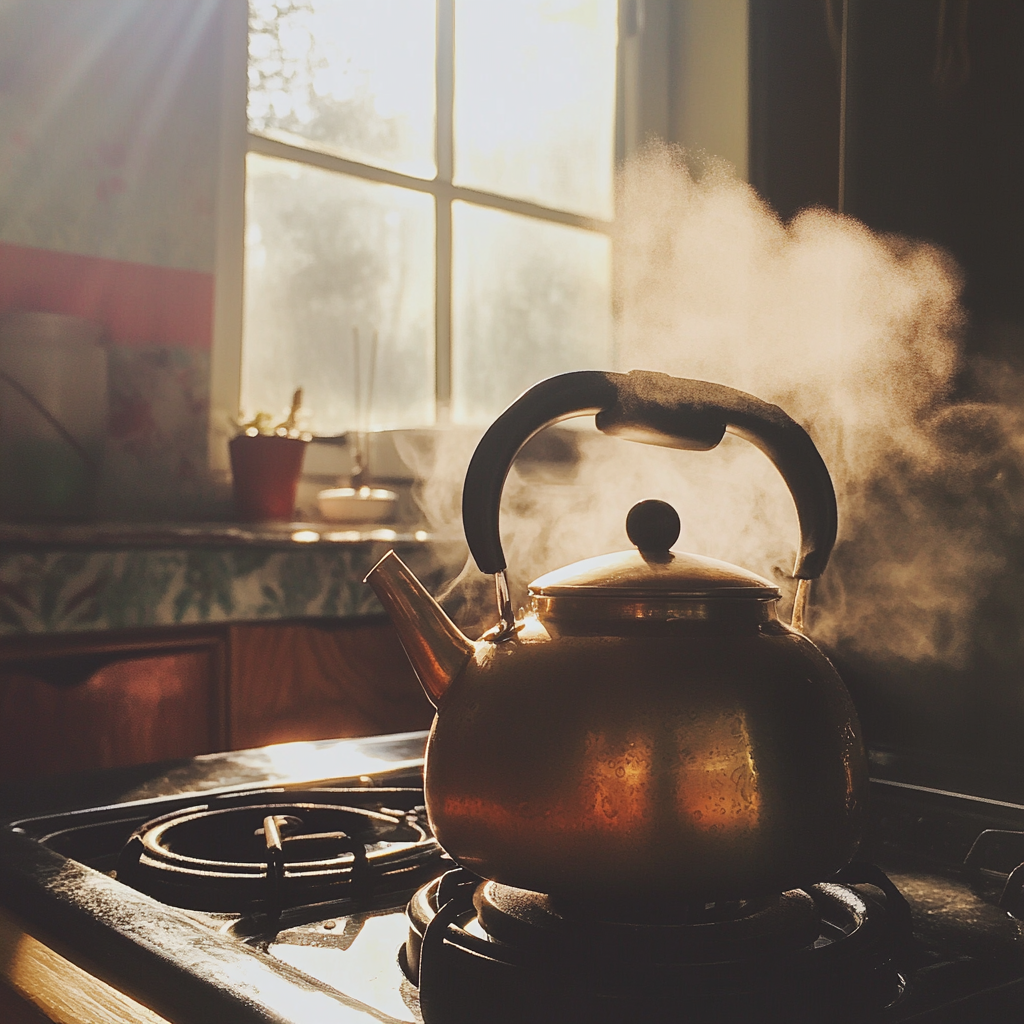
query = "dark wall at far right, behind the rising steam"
xmin=750 ymin=0 xmax=1024 ymax=772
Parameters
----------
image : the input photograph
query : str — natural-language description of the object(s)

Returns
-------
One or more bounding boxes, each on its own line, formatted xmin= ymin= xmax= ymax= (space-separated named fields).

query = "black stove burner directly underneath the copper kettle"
xmin=399 ymin=870 xmax=903 ymax=1024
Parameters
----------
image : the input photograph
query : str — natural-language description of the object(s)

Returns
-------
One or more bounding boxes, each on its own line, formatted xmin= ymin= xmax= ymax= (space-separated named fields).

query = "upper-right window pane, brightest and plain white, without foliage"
xmin=455 ymin=0 xmax=617 ymax=219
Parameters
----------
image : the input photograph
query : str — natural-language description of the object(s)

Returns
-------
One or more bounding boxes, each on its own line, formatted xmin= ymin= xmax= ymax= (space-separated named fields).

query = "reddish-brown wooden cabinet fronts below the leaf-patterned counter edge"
xmin=0 ymin=620 xmax=433 ymax=780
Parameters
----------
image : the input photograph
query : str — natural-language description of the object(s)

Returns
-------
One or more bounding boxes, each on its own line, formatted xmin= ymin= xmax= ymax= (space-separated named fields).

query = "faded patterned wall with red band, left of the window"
xmin=0 ymin=0 xmax=226 ymax=519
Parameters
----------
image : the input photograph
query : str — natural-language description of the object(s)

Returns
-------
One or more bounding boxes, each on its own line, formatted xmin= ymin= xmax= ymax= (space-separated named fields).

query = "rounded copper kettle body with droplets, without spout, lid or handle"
xmin=426 ymin=618 xmax=867 ymax=902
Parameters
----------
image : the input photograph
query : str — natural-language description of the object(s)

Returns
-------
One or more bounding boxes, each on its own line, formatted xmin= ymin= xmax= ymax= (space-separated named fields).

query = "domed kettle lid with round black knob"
xmin=529 ymin=501 xmax=779 ymax=601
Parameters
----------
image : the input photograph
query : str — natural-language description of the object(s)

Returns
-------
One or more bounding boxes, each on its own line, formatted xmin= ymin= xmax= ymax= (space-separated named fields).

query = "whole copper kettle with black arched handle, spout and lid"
xmin=367 ymin=371 xmax=867 ymax=902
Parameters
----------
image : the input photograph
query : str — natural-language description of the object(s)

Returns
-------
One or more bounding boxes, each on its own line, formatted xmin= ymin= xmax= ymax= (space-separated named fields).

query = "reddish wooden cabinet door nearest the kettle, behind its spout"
xmin=230 ymin=620 xmax=434 ymax=750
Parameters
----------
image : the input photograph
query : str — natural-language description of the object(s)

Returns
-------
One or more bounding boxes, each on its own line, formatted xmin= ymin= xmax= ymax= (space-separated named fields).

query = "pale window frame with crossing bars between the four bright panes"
xmin=209 ymin=0 xmax=746 ymax=472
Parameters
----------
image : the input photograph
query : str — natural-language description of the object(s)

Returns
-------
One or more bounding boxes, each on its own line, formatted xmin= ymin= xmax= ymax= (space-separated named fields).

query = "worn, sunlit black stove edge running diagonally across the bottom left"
xmin=0 ymin=830 xmax=407 ymax=1024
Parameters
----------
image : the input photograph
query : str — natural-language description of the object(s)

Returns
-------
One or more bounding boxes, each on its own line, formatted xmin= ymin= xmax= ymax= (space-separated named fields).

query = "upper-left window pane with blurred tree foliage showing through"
xmin=249 ymin=0 xmax=436 ymax=178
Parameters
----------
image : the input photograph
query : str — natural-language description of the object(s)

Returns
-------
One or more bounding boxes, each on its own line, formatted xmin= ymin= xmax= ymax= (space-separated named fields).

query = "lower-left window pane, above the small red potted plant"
xmin=242 ymin=153 xmax=434 ymax=434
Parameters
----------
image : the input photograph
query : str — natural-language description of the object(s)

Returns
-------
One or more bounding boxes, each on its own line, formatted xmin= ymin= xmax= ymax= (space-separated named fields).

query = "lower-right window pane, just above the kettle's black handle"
xmin=452 ymin=203 xmax=611 ymax=423
